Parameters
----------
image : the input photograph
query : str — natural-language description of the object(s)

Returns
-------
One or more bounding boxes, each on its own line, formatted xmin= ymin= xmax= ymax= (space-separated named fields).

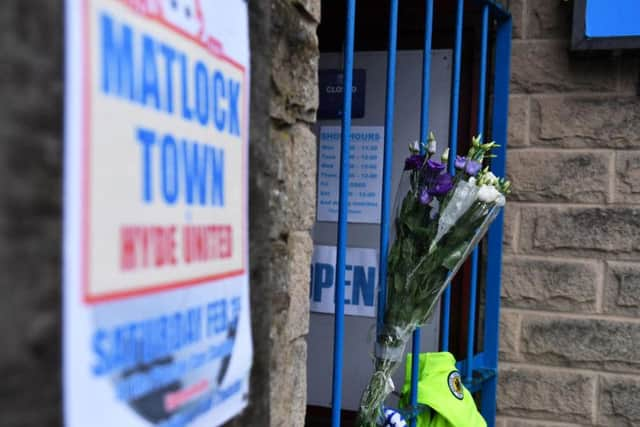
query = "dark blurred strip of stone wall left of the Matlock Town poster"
xmin=0 ymin=0 xmax=63 ymax=427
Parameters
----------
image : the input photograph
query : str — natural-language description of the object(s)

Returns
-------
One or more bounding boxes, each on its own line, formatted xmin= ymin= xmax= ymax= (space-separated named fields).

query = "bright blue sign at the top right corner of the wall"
xmin=585 ymin=0 xmax=640 ymax=38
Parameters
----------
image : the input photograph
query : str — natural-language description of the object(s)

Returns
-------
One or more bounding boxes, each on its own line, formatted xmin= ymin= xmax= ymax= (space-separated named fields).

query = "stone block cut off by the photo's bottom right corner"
xmin=598 ymin=377 xmax=640 ymax=427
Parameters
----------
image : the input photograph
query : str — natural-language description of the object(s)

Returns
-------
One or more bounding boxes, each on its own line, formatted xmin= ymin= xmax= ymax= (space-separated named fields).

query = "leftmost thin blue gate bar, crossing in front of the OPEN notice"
xmin=331 ymin=0 xmax=356 ymax=427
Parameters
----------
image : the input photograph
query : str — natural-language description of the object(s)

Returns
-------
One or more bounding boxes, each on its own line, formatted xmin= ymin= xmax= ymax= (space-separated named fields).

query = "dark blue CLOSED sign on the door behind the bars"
xmin=318 ymin=69 xmax=367 ymax=120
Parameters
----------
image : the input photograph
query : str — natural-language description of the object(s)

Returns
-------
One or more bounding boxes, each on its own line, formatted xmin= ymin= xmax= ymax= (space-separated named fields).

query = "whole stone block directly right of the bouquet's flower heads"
xmin=507 ymin=150 xmax=611 ymax=203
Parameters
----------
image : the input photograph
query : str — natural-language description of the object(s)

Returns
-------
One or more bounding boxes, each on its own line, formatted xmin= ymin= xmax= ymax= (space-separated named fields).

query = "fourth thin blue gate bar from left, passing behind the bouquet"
xmin=441 ymin=0 xmax=464 ymax=351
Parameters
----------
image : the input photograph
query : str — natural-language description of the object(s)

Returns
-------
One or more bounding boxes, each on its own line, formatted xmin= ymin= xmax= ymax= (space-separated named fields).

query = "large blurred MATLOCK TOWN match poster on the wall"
xmin=64 ymin=0 xmax=252 ymax=427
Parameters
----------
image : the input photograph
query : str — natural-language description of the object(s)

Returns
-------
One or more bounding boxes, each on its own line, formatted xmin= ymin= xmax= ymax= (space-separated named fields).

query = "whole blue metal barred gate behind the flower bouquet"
xmin=332 ymin=0 xmax=512 ymax=427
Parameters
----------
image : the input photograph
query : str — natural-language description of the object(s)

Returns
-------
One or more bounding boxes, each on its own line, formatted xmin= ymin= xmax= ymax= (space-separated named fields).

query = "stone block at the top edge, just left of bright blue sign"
xmin=525 ymin=0 xmax=573 ymax=40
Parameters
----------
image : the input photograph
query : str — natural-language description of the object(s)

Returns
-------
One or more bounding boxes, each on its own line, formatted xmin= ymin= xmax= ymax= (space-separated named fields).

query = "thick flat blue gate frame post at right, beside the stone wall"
xmin=481 ymin=13 xmax=512 ymax=427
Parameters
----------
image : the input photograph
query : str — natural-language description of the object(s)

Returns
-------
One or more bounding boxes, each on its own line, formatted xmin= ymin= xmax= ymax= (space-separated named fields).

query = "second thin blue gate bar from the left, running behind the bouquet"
xmin=376 ymin=0 xmax=398 ymax=335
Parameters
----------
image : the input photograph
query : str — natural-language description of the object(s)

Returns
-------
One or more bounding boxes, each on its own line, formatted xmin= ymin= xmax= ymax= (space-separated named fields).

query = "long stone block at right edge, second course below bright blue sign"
xmin=530 ymin=96 xmax=640 ymax=148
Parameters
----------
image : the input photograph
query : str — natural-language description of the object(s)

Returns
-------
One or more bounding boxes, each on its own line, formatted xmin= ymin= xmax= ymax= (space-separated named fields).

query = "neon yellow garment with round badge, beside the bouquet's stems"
xmin=400 ymin=353 xmax=487 ymax=427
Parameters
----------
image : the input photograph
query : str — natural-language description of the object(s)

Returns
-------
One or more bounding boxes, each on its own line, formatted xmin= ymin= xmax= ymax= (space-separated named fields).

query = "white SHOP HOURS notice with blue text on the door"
xmin=318 ymin=126 xmax=384 ymax=224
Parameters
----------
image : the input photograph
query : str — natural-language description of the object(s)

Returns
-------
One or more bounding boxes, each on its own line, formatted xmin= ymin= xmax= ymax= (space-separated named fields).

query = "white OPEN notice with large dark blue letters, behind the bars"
xmin=309 ymin=245 xmax=378 ymax=317
